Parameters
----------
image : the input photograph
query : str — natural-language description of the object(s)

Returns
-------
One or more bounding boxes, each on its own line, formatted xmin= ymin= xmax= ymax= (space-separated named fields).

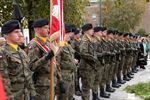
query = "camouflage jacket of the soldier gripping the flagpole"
xmin=28 ymin=38 xmax=50 ymax=86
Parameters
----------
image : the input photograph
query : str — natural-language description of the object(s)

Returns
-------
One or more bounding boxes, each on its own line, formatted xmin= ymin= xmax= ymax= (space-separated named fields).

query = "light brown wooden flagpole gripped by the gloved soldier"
xmin=50 ymin=0 xmax=55 ymax=100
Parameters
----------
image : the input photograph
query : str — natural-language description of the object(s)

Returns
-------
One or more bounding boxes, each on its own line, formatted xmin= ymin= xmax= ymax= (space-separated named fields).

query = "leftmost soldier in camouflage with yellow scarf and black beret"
xmin=0 ymin=20 xmax=36 ymax=100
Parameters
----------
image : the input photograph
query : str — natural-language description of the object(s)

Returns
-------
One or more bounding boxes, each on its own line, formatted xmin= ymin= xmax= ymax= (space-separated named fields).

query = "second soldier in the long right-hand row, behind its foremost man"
xmin=92 ymin=27 xmax=105 ymax=100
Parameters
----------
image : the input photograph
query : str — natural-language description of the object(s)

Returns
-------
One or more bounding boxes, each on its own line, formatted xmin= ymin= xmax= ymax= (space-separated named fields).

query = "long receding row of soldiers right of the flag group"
xmin=65 ymin=23 xmax=139 ymax=100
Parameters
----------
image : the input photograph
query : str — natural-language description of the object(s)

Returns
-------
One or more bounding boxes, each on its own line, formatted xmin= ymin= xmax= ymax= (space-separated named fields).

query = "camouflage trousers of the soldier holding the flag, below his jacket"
xmin=35 ymin=86 xmax=50 ymax=100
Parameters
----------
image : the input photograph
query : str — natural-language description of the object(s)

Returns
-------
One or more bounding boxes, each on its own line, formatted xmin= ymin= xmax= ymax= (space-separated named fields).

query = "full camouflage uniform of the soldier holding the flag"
xmin=28 ymin=37 xmax=50 ymax=100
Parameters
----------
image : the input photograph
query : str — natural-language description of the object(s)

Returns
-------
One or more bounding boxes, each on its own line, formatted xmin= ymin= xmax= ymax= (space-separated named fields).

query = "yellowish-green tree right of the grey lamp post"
xmin=103 ymin=0 xmax=145 ymax=31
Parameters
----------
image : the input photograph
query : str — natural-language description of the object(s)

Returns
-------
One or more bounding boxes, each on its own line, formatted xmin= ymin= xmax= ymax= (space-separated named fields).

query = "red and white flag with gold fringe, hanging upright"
xmin=50 ymin=0 xmax=65 ymax=42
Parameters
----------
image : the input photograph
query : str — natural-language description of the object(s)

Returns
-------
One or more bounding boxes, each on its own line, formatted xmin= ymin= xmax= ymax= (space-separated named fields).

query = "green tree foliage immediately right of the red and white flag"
xmin=63 ymin=0 xmax=89 ymax=27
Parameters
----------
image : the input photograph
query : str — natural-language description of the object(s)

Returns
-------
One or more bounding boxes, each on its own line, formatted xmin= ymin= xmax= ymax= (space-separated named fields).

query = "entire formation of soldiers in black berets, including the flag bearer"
xmin=0 ymin=19 xmax=139 ymax=100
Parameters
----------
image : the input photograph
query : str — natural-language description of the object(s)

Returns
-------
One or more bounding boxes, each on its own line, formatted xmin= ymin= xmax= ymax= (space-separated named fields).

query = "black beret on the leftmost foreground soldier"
xmin=1 ymin=20 xmax=21 ymax=35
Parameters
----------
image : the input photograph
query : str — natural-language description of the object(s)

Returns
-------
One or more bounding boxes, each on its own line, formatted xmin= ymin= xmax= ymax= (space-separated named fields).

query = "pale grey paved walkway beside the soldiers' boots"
xmin=75 ymin=60 xmax=150 ymax=100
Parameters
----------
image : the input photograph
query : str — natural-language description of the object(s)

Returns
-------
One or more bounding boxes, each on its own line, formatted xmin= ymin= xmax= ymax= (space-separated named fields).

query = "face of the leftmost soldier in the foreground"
xmin=5 ymin=29 xmax=21 ymax=44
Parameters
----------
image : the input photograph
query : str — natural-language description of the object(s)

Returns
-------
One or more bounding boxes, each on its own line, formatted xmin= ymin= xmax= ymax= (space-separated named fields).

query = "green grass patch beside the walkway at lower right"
xmin=124 ymin=82 xmax=150 ymax=100
